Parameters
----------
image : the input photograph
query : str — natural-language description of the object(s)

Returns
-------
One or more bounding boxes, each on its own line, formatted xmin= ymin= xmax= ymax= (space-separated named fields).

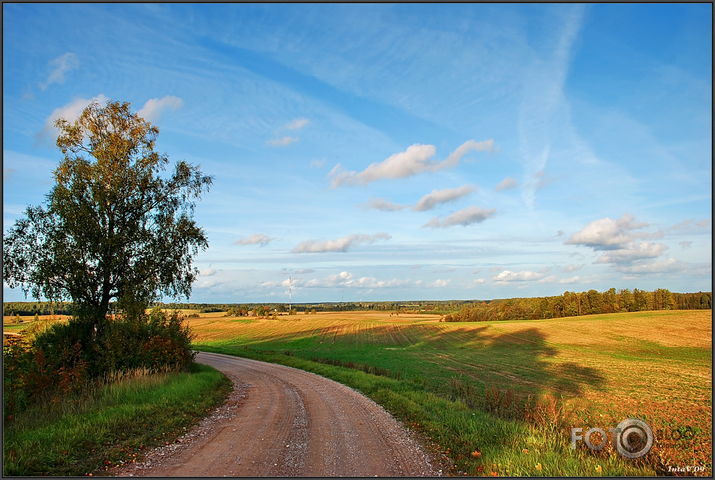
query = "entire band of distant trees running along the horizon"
xmin=3 ymin=288 xmax=712 ymax=322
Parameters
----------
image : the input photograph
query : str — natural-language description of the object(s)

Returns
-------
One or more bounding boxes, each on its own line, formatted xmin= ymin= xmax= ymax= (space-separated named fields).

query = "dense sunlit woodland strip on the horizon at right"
xmin=443 ymin=288 xmax=712 ymax=322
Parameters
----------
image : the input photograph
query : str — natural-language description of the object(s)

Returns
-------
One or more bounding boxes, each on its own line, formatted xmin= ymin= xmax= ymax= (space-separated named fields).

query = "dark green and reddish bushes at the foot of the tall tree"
xmin=3 ymin=309 xmax=195 ymax=420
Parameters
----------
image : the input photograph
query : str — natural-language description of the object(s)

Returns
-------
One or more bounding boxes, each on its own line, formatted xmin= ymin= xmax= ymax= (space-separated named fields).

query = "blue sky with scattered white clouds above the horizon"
xmin=3 ymin=4 xmax=712 ymax=302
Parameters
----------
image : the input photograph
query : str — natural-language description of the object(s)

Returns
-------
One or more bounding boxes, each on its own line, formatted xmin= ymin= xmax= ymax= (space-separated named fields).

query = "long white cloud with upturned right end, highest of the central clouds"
xmin=329 ymin=140 xmax=494 ymax=188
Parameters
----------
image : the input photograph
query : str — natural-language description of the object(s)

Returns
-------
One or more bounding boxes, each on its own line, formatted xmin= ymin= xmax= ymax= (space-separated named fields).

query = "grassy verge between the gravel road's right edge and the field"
xmin=195 ymin=344 xmax=655 ymax=476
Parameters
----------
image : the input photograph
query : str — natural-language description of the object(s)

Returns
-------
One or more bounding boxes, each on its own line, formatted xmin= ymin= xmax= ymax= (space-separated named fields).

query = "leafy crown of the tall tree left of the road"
xmin=3 ymin=102 xmax=212 ymax=327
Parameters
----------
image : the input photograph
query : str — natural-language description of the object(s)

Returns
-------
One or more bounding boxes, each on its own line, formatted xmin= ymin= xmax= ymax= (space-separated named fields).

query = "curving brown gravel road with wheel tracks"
xmin=113 ymin=353 xmax=442 ymax=477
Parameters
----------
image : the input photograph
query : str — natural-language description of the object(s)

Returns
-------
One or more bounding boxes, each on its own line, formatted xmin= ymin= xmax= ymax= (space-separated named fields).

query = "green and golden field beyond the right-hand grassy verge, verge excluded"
xmin=189 ymin=310 xmax=712 ymax=474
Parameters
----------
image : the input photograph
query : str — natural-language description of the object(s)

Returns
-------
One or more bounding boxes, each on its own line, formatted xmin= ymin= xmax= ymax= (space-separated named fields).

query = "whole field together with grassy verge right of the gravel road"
xmin=189 ymin=310 xmax=712 ymax=475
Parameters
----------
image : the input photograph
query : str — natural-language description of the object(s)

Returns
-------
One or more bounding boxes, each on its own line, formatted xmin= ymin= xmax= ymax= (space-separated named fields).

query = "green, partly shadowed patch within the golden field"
xmin=227 ymin=321 xmax=605 ymax=405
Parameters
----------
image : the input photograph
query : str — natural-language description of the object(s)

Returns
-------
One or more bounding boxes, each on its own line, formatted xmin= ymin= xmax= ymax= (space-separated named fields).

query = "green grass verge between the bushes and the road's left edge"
xmin=3 ymin=364 xmax=231 ymax=476
